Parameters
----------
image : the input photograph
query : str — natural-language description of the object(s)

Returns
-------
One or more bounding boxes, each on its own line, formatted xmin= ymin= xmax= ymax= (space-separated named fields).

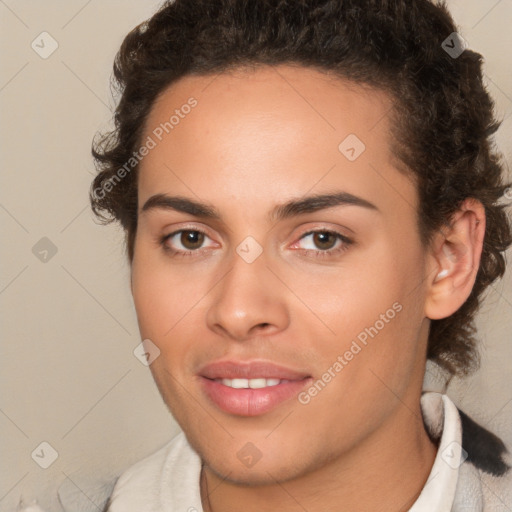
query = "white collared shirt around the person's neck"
xmin=108 ymin=392 xmax=512 ymax=512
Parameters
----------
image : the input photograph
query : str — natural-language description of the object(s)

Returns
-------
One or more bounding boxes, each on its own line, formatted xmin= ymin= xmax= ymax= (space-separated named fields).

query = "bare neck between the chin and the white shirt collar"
xmin=201 ymin=400 xmax=437 ymax=512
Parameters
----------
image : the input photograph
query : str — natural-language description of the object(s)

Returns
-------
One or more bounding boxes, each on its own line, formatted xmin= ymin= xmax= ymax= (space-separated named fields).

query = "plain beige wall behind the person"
xmin=0 ymin=0 xmax=512 ymax=511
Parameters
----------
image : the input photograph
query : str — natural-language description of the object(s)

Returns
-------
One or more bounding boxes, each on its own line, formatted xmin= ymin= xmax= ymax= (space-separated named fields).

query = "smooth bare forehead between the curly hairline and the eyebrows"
xmin=139 ymin=65 xmax=414 ymax=218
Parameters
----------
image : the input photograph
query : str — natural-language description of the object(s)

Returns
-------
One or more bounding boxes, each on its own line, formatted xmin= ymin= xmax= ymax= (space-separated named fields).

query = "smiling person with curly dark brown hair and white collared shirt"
xmin=91 ymin=0 xmax=512 ymax=512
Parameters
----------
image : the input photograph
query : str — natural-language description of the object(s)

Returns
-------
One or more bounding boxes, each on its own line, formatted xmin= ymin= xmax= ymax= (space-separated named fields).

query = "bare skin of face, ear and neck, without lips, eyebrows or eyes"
xmin=132 ymin=65 xmax=485 ymax=512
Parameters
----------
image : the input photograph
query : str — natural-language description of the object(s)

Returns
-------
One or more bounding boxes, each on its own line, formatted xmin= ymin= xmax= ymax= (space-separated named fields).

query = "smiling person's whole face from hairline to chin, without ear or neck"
xmin=132 ymin=66 xmax=428 ymax=483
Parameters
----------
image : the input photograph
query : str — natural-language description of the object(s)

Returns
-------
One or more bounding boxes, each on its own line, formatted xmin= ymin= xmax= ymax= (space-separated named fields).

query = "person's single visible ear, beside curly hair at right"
xmin=425 ymin=198 xmax=485 ymax=320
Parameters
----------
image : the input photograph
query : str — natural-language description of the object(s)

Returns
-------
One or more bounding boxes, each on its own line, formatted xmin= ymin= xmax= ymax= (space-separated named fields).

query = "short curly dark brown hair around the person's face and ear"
xmin=90 ymin=0 xmax=512 ymax=375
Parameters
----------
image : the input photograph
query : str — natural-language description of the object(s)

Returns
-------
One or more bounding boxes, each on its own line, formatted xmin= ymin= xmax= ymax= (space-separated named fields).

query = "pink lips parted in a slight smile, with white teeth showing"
xmin=198 ymin=361 xmax=311 ymax=416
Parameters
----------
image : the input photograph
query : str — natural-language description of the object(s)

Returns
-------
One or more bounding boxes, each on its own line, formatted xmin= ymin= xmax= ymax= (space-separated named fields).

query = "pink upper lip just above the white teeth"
xmin=198 ymin=361 xmax=309 ymax=380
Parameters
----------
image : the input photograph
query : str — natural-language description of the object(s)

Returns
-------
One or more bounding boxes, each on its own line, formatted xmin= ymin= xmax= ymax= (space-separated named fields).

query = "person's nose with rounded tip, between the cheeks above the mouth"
xmin=206 ymin=247 xmax=290 ymax=341
